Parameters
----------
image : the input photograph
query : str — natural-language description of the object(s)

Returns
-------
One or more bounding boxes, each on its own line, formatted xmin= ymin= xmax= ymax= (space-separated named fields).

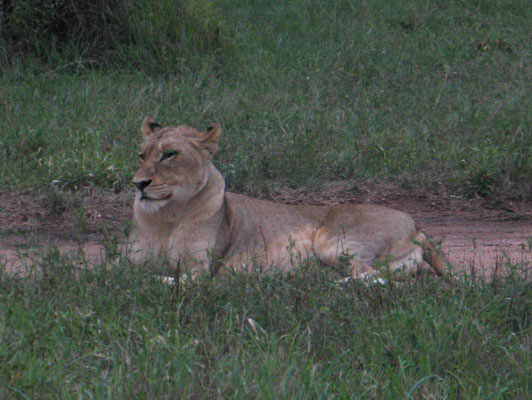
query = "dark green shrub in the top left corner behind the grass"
xmin=0 ymin=0 xmax=231 ymax=72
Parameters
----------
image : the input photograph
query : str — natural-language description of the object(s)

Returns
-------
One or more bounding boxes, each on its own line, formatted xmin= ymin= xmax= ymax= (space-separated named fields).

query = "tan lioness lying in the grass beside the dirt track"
xmin=129 ymin=117 xmax=446 ymax=278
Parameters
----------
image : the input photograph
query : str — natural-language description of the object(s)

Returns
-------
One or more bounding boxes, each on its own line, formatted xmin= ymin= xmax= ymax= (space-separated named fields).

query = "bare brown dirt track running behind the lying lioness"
xmin=0 ymin=182 xmax=532 ymax=277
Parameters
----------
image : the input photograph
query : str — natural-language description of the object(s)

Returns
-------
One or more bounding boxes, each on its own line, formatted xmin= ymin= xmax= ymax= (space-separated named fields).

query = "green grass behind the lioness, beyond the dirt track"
xmin=0 ymin=0 xmax=532 ymax=198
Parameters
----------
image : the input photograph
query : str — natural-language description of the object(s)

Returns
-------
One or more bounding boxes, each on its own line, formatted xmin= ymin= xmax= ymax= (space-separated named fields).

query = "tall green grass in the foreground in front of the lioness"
xmin=0 ymin=249 xmax=532 ymax=399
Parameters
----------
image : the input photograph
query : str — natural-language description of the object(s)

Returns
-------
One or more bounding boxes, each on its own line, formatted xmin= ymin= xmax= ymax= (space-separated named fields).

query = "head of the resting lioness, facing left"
xmin=133 ymin=117 xmax=221 ymax=212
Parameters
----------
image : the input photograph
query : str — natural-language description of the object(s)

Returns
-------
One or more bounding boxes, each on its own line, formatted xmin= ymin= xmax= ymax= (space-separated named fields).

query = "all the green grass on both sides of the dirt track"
xmin=0 ymin=0 xmax=532 ymax=399
